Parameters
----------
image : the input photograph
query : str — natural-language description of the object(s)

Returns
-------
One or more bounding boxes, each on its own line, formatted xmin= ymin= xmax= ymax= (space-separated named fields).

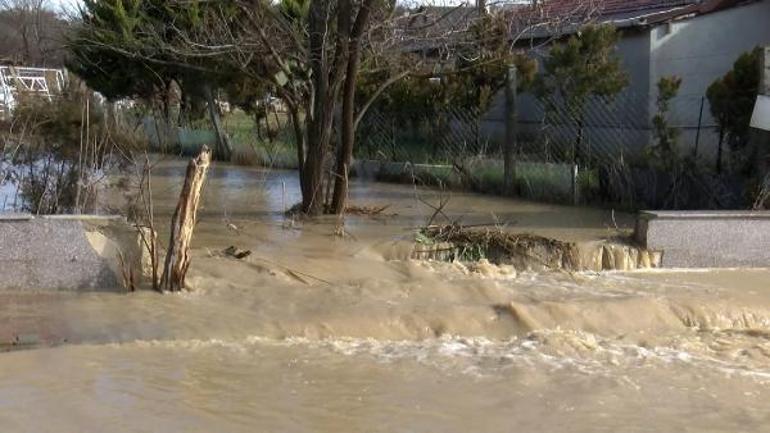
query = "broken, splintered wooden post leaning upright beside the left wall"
xmin=160 ymin=146 xmax=211 ymax=292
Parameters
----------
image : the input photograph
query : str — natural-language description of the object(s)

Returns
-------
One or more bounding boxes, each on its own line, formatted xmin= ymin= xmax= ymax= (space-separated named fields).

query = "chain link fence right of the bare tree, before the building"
xmin=356 ymin=92 xmax=748 ymax=209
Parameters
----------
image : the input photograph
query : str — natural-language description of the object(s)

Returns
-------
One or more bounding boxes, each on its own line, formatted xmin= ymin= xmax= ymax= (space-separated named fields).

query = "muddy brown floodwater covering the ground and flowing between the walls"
xmin=0 ymin=161 xmax=770 ymax=433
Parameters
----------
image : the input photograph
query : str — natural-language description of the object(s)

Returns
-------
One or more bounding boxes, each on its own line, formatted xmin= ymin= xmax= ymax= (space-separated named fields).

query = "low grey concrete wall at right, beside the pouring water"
xmin=636 ymin=211 xmax=770 ymax=268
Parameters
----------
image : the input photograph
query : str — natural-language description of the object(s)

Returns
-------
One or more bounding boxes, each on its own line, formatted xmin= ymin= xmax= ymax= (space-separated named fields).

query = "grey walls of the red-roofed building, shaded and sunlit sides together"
xmin=482 ymin=0 xmax=770 ymax=164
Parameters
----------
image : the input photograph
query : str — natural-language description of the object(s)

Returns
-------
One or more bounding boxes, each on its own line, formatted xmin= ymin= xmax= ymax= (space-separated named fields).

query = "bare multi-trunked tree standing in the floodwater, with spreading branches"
xmin=69 ymin=0 xmax=598 ymax=215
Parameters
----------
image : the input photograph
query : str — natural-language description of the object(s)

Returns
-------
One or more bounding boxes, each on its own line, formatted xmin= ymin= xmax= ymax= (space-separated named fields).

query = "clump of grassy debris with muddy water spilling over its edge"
xmin=412 ymin=224 xmax=660 ymax=271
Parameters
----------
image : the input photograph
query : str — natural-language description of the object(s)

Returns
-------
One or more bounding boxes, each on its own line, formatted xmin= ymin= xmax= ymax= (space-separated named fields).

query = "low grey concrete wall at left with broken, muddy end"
xmin=0 ymin=215 xmax=142 ymax=290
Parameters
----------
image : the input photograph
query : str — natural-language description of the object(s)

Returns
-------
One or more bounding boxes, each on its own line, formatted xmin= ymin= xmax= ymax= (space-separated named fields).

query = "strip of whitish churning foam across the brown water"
xmin=109 ymin=331 xmax=770 ymax=383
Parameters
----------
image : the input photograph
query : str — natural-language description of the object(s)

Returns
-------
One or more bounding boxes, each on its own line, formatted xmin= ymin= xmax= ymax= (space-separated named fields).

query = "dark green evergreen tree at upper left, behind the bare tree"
xmin=68 ymin=0 xmax=237 ymax=159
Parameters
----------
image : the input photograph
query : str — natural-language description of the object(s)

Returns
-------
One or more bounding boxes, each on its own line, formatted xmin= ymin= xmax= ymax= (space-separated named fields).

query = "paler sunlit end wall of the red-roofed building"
xmin=650 ymin=0 xmax=770 ymax=157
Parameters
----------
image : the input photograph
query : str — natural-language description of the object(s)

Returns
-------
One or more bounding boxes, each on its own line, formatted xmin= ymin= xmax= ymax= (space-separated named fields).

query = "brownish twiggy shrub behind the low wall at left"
xmin=0 ymin=85 xmax=146 ymax=214
